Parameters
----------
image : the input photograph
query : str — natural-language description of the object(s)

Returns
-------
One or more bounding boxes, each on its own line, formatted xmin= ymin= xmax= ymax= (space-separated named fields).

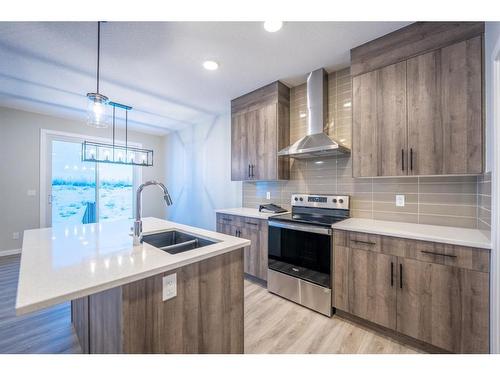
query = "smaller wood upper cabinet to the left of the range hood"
xmin=231 ymin=81 xmax=290 ymax=181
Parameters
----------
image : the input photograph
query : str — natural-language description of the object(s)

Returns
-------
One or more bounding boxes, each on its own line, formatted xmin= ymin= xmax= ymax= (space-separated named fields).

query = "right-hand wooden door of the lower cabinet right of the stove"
xmin=397 ymin=258 xmax=489 ymax=353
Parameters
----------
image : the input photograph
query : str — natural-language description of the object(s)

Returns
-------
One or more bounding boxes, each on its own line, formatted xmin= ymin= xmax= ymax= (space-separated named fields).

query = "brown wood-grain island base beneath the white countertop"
xmin=72 ymin=249 xmax=244 ymax=354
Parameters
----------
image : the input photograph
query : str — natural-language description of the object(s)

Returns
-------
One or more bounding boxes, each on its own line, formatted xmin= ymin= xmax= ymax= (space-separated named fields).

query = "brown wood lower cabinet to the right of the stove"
xmin=333 ymin=230 xmax=490 ymax=353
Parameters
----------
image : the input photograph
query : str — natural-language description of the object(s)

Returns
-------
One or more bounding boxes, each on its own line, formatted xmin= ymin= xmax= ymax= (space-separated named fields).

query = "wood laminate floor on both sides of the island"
xmin=0 ymin=256 xmax=416 ymax=353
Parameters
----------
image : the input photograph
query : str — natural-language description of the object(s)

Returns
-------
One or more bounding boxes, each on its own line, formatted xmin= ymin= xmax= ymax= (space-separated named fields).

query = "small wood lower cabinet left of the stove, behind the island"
xmin=217 ymin=213 xmax=268 ymax=281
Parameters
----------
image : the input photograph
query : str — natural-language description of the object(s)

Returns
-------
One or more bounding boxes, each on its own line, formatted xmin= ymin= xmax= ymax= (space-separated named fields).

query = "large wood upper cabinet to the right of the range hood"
xmin=351 ymin=22 xmax=484 ymax=177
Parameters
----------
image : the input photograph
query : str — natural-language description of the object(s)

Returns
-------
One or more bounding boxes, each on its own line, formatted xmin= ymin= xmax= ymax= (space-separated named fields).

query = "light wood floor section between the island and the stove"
xmin=245 ymin=280 xmax=418 ymax=354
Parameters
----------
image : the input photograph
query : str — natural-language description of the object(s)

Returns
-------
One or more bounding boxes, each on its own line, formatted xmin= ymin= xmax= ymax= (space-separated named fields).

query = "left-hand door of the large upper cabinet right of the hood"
xmin=353 ymin=62 xmax=408 ymax=177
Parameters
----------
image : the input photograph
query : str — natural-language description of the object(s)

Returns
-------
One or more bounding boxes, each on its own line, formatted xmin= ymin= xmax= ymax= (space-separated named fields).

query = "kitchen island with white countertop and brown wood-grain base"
xmin=16 ymin=218 xmax=250 ymax=353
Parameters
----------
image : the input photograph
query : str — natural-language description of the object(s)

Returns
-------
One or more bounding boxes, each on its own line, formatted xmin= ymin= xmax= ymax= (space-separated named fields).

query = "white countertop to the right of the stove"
xmin=332 ymin=218 xmax=491 ymax=249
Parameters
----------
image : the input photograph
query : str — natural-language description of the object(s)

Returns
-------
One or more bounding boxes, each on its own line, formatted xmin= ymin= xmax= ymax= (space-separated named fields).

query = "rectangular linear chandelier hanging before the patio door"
xmin=82 ymin=101 xmax=153 ymax=167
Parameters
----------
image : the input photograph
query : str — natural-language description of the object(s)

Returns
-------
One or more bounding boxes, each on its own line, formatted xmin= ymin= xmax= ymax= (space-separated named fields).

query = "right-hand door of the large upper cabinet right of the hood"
xmin=407 ymin=37 xmax=483 ymax=175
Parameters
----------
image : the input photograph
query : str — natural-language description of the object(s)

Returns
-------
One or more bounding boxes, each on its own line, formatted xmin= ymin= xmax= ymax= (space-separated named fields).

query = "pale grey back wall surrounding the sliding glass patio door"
xmin=0 ymin=107 xmax=165 ymax=251
